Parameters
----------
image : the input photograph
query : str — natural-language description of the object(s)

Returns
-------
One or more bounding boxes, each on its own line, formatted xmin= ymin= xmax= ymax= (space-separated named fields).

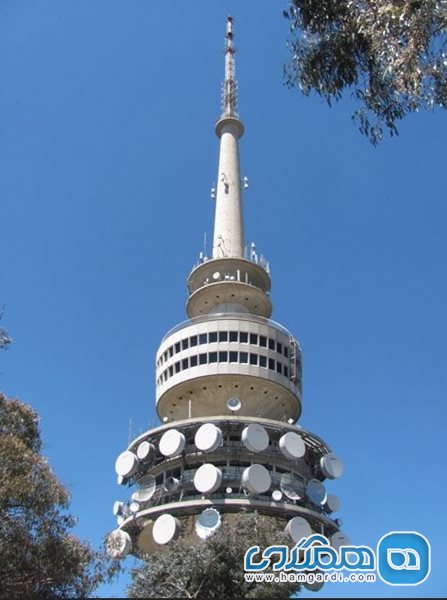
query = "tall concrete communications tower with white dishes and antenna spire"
xmin=108 ymin=17 xmax=348 ymax=572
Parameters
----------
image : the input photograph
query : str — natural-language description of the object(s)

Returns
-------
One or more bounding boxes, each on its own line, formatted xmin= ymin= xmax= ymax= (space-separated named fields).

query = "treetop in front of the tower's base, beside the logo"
xmin=128 ymin=513 xmax=299 ymax=600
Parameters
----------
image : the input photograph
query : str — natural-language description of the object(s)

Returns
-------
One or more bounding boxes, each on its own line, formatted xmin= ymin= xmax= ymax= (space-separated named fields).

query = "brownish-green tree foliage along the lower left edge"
xmin=0 ymin=393 xmax=121 ymax=599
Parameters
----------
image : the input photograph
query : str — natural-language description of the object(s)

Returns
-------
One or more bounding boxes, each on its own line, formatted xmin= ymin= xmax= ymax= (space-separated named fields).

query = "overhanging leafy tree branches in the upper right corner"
xmin=284 ymin=0 xmax=447 ymax=144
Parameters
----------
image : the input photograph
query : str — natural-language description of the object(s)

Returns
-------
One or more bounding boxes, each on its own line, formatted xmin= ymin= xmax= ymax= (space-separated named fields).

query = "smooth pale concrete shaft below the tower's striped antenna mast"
xmin=213 ymin=117 xmax=245 ymax=258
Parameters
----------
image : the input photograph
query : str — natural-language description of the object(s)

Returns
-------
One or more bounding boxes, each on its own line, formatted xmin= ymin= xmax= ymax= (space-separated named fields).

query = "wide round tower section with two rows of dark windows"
xmin=156 ymin=313 xmax=301 ymax=421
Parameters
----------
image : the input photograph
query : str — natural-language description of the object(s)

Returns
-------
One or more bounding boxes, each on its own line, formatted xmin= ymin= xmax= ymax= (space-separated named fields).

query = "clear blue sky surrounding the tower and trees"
xmin=0 ymin=0 xmax=447 ymax=598
